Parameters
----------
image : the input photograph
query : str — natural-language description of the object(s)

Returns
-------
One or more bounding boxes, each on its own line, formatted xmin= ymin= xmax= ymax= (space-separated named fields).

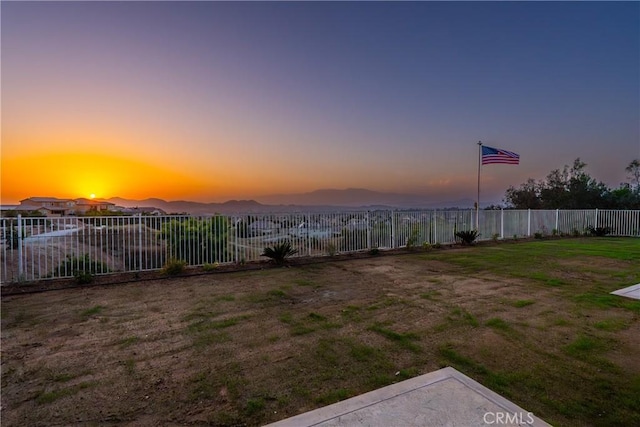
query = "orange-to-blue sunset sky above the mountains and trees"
xmin=1 ymin=2 xmax=640 ymax=204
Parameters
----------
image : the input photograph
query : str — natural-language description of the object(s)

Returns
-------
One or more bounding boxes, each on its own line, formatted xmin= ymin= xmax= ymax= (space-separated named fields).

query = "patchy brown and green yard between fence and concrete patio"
xmin=2 ymin=238 xmax=640 ymax=426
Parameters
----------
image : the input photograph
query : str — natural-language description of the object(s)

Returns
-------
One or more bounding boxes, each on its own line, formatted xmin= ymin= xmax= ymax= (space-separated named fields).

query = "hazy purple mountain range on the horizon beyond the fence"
xmin=107 ymin=188 xmax=473 ymax=215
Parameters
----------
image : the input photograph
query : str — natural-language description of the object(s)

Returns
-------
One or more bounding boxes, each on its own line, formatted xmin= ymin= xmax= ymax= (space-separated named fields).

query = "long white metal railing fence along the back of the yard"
xmin=0 ymin=209 xmax=640 ymax=284
